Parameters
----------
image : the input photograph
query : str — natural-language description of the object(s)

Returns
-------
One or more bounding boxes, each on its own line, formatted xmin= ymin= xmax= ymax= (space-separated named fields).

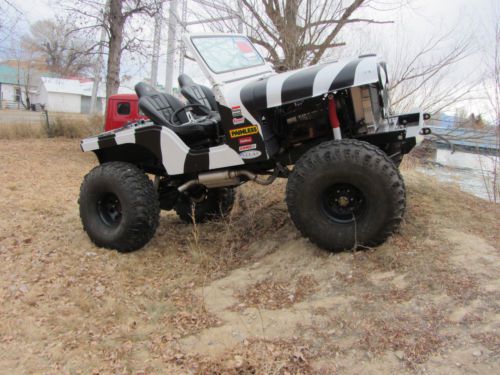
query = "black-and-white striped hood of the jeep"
xmin=240 ymin=55 xmax=387 ymax=113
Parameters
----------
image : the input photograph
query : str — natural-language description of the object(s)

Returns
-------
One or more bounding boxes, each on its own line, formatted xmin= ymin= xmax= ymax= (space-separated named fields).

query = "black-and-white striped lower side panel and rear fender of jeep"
xmin=81 ymin=123 xmax=244 ymax=176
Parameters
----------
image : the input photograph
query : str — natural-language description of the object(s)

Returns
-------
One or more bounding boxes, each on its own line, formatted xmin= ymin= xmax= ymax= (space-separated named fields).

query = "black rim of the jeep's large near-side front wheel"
xmin=321 ymin=184 xmax=366 ymax=224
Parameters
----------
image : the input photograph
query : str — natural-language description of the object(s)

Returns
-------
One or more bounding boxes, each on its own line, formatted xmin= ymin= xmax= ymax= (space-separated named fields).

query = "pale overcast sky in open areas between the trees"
xmin=0 ymin=0 xmax=500 ymax=117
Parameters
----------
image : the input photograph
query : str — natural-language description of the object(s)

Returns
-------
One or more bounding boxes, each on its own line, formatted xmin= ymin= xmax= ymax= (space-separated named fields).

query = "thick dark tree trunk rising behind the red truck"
xmin=106 ymin=0 xmax=125 ymax=98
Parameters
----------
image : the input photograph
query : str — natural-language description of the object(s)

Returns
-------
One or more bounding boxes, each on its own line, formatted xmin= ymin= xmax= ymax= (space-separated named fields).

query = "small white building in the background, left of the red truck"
xmin=36 ymin=77 xmax=106 ymax=113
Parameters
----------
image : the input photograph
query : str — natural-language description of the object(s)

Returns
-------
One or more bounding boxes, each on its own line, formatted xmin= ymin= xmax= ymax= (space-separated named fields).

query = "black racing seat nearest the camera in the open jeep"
xmin=135 ymin=82 xmax=218 ymax=147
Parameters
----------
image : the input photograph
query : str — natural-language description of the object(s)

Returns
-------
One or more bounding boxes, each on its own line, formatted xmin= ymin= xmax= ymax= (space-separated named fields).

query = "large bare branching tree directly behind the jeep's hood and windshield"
xmin=195 ymin=0 xmax=392 ymax=70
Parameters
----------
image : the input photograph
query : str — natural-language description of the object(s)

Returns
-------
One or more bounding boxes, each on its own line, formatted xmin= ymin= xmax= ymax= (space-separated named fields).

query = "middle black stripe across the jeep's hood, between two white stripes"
xmin=281 ymin=64 xmax=325 ymax=104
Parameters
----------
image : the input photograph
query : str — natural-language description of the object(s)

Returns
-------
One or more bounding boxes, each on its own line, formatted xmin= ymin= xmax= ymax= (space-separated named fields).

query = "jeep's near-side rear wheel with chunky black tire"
xmin=78 ymin=162 xmax=160 ymax=252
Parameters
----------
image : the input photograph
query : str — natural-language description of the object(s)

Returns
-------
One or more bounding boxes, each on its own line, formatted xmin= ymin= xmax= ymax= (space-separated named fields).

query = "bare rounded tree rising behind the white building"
xmin=22 ymin=18 xmax=95 ymax=77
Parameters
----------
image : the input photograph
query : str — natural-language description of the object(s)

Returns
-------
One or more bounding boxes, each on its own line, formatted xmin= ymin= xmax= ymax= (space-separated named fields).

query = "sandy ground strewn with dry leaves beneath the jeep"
xmin=0 ymin=139 xmax=500 ymax=374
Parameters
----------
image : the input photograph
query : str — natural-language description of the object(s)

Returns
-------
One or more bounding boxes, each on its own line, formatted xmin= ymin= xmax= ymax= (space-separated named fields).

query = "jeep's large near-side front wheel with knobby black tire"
xmin=286 ymin=140 xmax=406 ymax=251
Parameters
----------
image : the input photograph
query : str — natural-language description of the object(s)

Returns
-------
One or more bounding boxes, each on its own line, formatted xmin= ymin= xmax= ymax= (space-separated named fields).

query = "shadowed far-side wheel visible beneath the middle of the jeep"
xmin=174 ymin=186 xmax=234 ymax=223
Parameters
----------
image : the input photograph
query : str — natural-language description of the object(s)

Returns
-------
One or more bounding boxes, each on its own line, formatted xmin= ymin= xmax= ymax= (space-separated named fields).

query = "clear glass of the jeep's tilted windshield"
xmin=191 ymin=36 xmax=264 ymax=73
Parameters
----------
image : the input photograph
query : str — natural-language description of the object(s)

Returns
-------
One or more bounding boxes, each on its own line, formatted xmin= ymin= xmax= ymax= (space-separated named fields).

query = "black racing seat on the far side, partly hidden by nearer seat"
xmin=177 ymin=74 xmax=220 ymax=121
